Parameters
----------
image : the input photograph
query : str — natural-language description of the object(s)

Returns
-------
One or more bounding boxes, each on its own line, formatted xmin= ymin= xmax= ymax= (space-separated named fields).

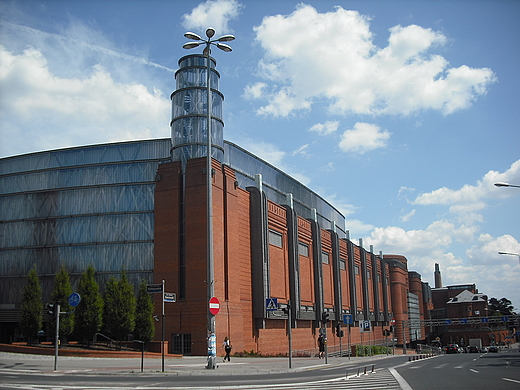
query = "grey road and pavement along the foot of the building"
xmin=0 ymin=349 xmax=520 ymax=390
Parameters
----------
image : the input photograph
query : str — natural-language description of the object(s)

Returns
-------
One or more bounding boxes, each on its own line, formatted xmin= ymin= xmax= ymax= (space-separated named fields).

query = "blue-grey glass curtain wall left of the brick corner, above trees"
xmin=0 ymin=138 xmax=171 ymax=316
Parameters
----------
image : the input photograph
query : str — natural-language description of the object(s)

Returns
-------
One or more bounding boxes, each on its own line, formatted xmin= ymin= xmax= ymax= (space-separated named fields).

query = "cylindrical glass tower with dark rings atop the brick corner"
xmin=170 ymin=54 xmax=224 ymax=166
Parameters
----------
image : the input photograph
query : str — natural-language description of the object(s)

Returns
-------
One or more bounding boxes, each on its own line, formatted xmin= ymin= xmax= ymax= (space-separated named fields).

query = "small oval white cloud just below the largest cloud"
xmin=339 ymin=122 xmax=391 ymax=154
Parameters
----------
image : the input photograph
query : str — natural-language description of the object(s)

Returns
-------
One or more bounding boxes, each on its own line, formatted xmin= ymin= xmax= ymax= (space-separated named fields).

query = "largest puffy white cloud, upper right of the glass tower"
xmin=254 ymin=4 xmax=496 ymax=117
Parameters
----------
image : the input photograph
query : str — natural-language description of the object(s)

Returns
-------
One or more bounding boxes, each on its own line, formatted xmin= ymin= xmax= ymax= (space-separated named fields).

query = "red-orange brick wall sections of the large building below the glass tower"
xmin=154 ymin=158 xmax=418 ymax=355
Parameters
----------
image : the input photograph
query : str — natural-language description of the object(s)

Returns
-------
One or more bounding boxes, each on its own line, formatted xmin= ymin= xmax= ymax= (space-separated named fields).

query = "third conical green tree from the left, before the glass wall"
xmin=75 ymin=266 xmax=103 ymax=343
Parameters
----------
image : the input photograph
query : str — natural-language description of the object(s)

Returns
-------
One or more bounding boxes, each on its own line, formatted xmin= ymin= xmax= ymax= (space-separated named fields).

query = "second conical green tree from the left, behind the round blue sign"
xmin=47 ymin=265 xmax=74 ymax=340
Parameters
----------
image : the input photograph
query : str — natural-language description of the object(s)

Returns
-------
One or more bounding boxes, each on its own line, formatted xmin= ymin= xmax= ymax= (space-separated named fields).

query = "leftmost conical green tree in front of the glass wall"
xmin=20 ymin=266 xmax=43 ymax=344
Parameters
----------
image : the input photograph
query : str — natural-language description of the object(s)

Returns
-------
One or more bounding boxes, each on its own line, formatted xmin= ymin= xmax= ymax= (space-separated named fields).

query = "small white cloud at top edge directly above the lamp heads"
xmin=182 ymin=0 xmax=243 ymax=36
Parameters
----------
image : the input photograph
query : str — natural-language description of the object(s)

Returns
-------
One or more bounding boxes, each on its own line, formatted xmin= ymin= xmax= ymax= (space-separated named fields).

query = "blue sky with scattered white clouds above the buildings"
xmin=0 ymin=0 xmax=520 ymax=310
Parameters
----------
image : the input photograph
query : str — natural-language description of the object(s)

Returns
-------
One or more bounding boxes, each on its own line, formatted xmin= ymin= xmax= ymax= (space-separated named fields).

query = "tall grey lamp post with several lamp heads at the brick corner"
xmin=182 ymin=27 xmax=235 ymax=369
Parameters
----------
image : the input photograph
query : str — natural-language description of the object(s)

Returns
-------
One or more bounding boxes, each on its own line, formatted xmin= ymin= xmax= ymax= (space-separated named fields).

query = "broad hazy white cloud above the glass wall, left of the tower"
xmin=0 ymin=46 xmax=169 ymax=156
